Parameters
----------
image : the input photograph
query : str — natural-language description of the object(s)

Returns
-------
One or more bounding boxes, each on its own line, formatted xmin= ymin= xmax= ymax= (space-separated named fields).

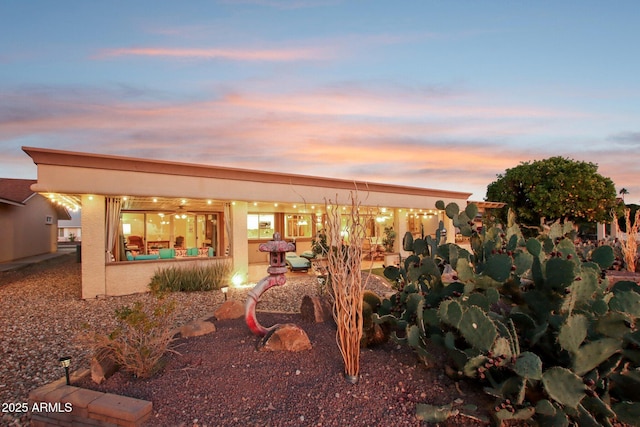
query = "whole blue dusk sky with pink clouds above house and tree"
xmin=0 ymin=0 xmax=640 ymax=204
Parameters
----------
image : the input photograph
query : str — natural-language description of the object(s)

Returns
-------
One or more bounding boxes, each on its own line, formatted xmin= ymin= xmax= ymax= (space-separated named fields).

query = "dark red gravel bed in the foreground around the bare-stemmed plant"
xmin=79 ymin=313 xmax=490 ymax=427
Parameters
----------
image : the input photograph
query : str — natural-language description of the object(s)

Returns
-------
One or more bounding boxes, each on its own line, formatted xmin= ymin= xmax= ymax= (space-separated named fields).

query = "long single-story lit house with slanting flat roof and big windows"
xmin=23 ymin=147 xmax=471 ymax=298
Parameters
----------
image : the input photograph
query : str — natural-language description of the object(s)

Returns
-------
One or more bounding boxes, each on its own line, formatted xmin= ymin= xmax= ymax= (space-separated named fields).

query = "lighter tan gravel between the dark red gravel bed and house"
xmin=0 ymin=254 xmax=396 ymax=426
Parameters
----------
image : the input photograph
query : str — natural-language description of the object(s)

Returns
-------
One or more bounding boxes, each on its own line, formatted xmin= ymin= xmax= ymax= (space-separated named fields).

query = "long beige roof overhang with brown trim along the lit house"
xmin=22 ymin=147 xmax=471 ymax=209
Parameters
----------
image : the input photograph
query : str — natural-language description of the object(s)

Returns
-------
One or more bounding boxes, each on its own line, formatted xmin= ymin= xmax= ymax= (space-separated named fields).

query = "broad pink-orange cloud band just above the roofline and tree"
xmin=0 ymin=85 xmax=640 ymax=204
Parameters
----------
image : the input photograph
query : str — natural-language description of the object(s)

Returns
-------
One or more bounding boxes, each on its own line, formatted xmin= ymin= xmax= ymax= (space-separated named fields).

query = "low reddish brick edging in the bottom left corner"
xmin=29 ymin=369 xmax=153 ymax=427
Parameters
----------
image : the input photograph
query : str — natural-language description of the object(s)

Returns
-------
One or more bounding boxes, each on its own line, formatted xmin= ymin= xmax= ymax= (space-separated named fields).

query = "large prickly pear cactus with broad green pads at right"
xmin=373 ymin=205 xmax=640 ymax=425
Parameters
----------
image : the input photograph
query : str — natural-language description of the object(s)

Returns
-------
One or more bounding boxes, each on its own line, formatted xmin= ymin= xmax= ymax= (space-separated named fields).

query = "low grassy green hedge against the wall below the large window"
xmin=149 ymin=261 xmax=231 ymax=292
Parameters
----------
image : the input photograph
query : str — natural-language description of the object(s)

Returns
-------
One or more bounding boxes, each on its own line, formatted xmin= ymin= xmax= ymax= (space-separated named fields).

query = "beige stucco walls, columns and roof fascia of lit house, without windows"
xmin=23 ymin=147 xmax=470 ymax=298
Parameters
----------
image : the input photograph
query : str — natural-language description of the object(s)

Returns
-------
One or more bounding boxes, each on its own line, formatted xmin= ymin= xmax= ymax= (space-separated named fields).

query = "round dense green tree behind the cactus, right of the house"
xmin=486 ymin=157 xmax=617 ymax=225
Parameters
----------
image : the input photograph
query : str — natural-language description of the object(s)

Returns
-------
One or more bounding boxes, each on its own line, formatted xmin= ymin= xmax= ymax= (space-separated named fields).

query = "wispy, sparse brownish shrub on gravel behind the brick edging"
xmin=91 ymin=295 xmax=175 ymax=378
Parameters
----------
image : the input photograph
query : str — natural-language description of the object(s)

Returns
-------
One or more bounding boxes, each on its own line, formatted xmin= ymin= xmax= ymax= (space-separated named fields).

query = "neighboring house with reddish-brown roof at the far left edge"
xmin=0 ymin=178 xmax=71 ymax=262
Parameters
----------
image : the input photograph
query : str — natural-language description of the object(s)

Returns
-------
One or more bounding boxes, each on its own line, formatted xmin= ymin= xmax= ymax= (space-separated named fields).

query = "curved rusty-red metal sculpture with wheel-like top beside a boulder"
xmin=244 ymin=233 xmax=296 ymax=337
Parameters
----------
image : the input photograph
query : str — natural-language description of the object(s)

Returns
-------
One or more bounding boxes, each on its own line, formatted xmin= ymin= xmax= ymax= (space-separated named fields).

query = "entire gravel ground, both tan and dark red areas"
xmin=0 ymin=254 xmax=636 ymax=427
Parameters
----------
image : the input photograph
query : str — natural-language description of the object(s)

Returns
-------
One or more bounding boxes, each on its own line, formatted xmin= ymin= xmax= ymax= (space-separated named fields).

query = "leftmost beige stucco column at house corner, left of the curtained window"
xmin=81 ymin=194 xmax=107 ymax=299
